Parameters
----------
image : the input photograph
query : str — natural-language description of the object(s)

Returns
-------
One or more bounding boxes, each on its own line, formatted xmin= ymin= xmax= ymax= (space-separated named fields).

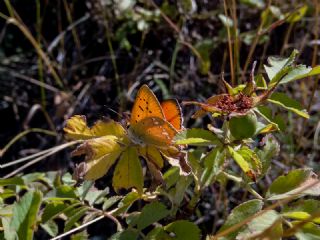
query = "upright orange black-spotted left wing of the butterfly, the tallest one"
xmin=130 ymin=85 xmax=165 ymax=126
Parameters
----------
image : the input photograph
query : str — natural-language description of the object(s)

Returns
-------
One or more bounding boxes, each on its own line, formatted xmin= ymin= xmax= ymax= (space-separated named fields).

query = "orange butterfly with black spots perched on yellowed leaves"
xmin=128 ymin=85 xmax=183 ymax=148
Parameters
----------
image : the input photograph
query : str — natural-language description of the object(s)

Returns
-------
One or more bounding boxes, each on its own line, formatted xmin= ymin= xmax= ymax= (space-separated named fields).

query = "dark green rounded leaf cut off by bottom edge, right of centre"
xmin=164 ymin=220 xmax=200 ymax=240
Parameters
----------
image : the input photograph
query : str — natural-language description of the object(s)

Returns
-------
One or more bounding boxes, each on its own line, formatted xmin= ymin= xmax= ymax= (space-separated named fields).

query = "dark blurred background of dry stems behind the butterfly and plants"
xmin=0 ymin=0 xmax=320 ymax=236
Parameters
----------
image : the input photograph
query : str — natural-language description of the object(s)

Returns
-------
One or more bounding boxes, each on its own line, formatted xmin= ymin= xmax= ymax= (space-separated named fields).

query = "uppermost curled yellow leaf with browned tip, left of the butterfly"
xmin=63 ymin=115 xmax=126 ymax=140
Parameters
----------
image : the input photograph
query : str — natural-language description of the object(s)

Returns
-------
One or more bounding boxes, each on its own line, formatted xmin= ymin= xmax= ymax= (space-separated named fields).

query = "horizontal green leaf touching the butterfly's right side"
xmin=174 ymin=128 xmax=220 ymax=146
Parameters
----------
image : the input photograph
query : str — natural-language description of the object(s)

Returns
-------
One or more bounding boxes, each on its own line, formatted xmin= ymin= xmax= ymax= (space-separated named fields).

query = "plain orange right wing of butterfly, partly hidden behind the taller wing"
xmin=161 ymin=99 xmax=183 ymax=131
